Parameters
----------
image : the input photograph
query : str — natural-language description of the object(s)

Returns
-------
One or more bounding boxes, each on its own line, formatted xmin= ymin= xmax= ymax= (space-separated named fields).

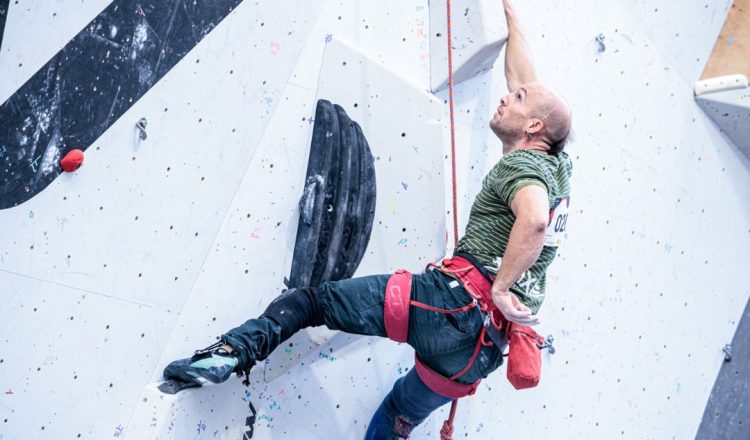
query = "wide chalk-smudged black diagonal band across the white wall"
xmin=0 ymin=0 xmax=242 ymax=209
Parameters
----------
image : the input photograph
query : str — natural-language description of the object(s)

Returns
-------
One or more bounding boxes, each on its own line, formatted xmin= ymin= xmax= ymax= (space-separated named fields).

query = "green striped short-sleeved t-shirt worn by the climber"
xmin=456 ymin=150 xmax=572 ymax=313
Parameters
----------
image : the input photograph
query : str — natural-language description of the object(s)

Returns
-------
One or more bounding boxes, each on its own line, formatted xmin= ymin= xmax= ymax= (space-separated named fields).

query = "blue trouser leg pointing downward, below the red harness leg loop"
xmin=365 ymin=368 xmax=451 ymax=440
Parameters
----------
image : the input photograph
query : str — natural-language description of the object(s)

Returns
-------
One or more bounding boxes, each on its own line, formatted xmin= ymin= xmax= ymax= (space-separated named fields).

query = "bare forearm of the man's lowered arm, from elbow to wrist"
xmin=492 ymin=219 xmax=546 ymax=295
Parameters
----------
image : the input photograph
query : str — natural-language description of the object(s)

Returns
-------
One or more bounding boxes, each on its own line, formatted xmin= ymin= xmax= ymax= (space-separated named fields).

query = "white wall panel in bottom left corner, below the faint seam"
xmin=0 ymin=271 xmax=167 ymax=439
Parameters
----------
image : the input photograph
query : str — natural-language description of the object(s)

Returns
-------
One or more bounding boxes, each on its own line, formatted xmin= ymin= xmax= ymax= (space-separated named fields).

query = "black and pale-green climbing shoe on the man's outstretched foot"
xmin=159 ymin=341 xmax=239 ymax=394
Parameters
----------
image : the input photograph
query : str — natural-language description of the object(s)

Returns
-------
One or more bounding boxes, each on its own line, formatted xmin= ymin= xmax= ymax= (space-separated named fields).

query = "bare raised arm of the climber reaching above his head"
xmin=503 ymin=0 xmax=536 ymax=92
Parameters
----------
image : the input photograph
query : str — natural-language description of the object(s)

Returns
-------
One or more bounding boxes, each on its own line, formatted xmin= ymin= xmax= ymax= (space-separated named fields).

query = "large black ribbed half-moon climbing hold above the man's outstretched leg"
xmin=287 ymin=100 xmax=376 ymax=288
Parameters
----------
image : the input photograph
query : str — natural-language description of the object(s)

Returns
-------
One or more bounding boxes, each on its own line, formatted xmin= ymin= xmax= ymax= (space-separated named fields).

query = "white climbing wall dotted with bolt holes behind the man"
xmin=0 ymin=0 xmax=750 ymax=440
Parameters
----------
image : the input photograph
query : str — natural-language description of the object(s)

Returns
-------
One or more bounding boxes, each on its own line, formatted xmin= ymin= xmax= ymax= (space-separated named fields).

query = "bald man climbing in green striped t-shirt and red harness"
xmin=164 ymin=0 xmax=571 ymax=439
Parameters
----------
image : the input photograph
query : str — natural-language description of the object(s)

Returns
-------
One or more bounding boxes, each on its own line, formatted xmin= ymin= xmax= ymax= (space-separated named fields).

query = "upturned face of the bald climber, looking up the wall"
xmin=490 ymin=85 xmax=533 ymax=152
